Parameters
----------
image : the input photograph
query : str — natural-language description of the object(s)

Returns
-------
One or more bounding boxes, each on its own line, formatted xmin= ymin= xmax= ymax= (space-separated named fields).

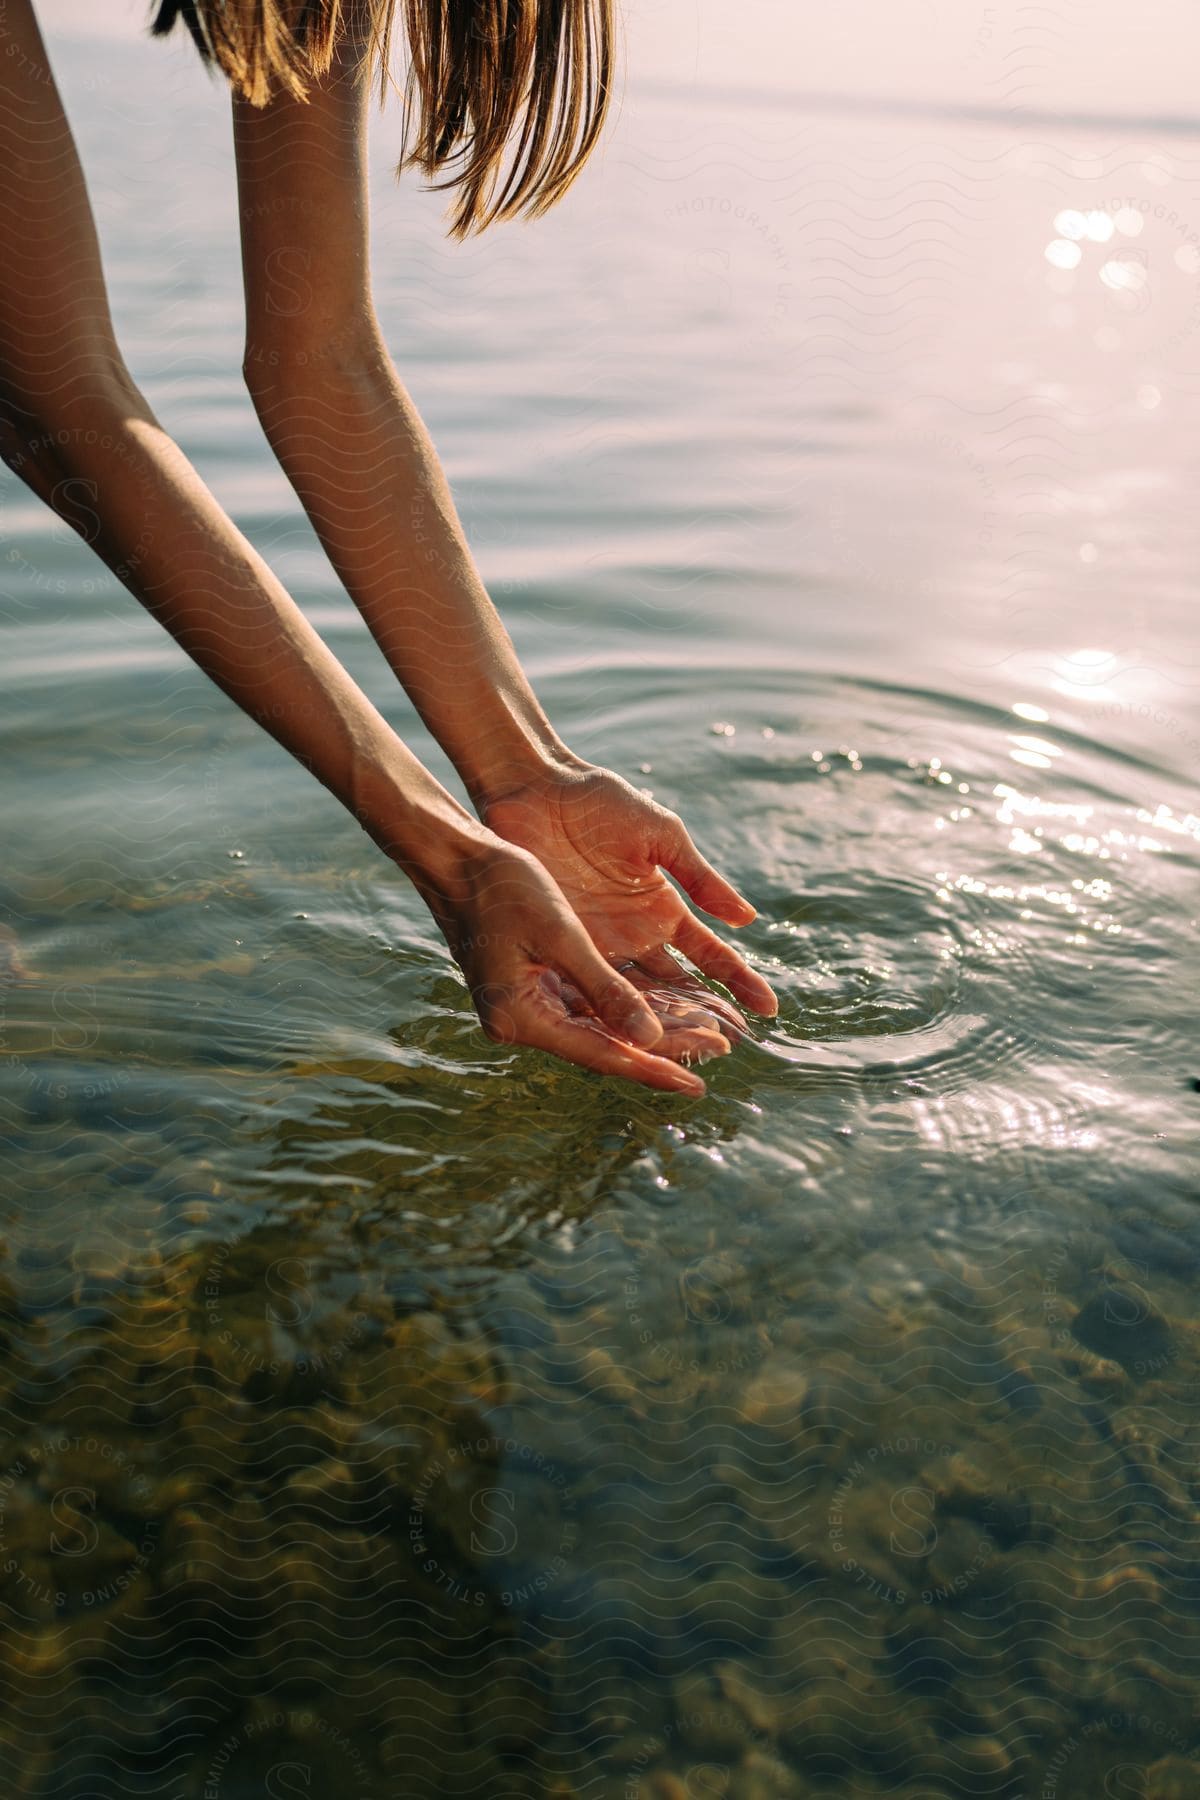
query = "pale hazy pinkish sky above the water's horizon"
xmin=38 ymin=0 xmax=1200 ymax=115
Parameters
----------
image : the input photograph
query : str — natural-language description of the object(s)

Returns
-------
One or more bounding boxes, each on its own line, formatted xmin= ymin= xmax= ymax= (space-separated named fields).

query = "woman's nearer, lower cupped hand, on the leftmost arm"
xmin=414 ymin=832 xmax=729 ymax=1094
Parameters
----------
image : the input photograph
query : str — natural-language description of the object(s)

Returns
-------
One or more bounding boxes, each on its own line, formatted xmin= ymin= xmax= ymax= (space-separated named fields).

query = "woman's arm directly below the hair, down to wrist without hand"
xmin=234 ymin=8 xmax=581 ymax=806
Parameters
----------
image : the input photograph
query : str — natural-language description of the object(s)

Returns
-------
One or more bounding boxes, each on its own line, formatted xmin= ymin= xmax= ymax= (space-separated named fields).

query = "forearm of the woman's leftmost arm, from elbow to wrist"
xmin=4 ymin=387 xmax=479 ymax=884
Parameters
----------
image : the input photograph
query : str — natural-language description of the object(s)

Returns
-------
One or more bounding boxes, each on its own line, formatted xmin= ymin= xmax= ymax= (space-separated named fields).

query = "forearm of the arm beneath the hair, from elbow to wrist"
xmin=246 ymin=331 xmax=579 ymax=806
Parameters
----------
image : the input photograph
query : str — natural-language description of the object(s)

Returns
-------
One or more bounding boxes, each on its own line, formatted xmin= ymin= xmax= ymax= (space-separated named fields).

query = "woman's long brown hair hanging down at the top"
xmin=151 ymin=0 xmax=615 ymax=238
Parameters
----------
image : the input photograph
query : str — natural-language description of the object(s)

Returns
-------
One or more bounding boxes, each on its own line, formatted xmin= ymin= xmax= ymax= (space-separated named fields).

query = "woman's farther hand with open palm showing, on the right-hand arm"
xmin=482 ymin=763 xmax=779 ymax=1037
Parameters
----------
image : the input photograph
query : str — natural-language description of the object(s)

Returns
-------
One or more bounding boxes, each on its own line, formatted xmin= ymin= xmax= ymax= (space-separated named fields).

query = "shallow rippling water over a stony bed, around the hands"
xmin=0 ymin=14 xmax=1200 ymax=1800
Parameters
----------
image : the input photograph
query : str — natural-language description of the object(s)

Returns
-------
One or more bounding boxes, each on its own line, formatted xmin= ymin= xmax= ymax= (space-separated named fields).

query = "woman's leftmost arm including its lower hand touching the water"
xmin=0 ymin=0 xmax=723 ymax=1093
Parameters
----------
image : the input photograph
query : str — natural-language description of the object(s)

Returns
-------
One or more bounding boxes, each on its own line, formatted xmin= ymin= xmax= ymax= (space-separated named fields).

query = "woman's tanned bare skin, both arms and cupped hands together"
xmin=0 ymin=0 xmax=775 ymax=1094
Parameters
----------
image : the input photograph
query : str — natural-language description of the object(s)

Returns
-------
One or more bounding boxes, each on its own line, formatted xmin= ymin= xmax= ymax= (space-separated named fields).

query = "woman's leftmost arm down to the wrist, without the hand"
xmin=0 ymin=0 xmax=479 ymax=892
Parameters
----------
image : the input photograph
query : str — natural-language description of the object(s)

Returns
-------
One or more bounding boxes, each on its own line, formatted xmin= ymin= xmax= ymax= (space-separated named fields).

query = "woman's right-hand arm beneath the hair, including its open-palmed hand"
xmin=234 ymin=14 xmax=775 ymax=1030
